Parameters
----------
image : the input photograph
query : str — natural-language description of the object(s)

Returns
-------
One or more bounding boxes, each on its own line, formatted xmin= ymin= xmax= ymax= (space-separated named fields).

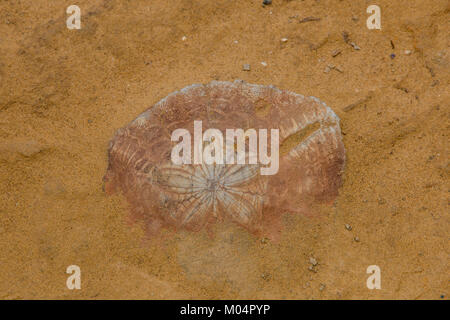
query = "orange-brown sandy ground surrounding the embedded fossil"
xmin=0 ymin=0 xmax=450 ymax=299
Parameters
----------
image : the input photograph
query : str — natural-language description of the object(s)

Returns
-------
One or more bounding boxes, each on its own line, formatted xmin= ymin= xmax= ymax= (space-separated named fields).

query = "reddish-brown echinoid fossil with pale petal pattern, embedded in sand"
xmin=104 ymin=80 xmax=345 ymax=236
